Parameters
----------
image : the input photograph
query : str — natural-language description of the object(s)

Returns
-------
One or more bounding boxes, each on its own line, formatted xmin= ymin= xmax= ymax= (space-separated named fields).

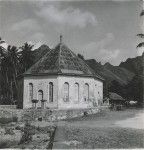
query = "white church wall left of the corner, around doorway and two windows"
xmin=23 ymin=76 xmax=58 ymax=108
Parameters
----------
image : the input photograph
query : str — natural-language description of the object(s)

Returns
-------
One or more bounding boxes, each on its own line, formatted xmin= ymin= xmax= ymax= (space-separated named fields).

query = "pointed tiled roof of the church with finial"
xmin=24 ymin=36 xmax=103 ymax=80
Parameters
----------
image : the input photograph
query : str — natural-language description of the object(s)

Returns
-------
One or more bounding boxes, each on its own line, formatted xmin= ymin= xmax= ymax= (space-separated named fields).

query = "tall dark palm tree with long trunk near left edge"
xmin=1 ymin=45 xmax=19 ymax=103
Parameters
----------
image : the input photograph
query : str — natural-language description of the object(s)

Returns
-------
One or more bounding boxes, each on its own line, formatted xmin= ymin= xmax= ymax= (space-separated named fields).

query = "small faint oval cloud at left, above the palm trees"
xmin=11 ymin=19 xmax=40 ymax=32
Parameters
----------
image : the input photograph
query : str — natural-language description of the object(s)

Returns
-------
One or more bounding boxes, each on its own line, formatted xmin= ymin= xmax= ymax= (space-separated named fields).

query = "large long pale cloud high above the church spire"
xmin=36 ymin=5 xmax=97 ymax=28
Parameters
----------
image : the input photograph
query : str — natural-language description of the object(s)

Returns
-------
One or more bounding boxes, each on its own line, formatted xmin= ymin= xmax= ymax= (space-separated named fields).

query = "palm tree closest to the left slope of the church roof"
xmin=20 ymin=42 xmax=34 ymax=73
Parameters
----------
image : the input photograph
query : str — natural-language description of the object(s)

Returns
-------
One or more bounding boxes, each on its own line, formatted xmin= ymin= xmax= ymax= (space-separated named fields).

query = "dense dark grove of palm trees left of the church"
xmin=0 ymin=38 xmax=33 ymax=104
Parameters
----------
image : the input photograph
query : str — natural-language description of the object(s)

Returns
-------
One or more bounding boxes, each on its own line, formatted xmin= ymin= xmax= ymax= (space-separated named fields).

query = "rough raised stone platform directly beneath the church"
xmin=21 ymin=108 xmax=99 ymax=121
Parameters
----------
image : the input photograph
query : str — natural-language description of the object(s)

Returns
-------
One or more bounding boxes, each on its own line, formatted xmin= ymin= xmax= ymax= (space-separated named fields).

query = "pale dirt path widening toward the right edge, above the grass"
xmin=54 ymin=110 xmax=144 ymax=129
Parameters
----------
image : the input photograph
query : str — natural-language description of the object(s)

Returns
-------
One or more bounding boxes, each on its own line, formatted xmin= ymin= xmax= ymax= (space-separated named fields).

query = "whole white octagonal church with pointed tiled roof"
xmin=19 ymin=36 xmax=103 ymax=109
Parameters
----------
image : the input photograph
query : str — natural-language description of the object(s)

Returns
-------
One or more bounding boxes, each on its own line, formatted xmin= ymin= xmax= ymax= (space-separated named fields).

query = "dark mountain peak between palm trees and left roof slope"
xmin=33 ymin=45 xmax=51 ymax=63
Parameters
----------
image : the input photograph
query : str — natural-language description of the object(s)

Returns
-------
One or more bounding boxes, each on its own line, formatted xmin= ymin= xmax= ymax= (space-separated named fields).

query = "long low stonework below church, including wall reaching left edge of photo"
xmin=0 ymin=108 xmax=100 ymax=121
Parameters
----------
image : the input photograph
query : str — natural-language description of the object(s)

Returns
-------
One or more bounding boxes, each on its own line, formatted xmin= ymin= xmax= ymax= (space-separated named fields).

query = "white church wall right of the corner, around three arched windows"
xmin=58 ymin=76 xmax=103 ymax=109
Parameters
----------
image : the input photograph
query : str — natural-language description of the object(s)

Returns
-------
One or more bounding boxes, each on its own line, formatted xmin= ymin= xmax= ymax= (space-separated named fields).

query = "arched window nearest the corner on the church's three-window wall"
xmin=63 ymin=82 xmax=69 ymax=102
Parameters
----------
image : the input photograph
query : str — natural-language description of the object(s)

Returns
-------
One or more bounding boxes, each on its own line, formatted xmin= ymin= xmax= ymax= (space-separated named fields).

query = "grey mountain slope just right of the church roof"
xmin=86 ymin=59 xmax=134 ymax=85
